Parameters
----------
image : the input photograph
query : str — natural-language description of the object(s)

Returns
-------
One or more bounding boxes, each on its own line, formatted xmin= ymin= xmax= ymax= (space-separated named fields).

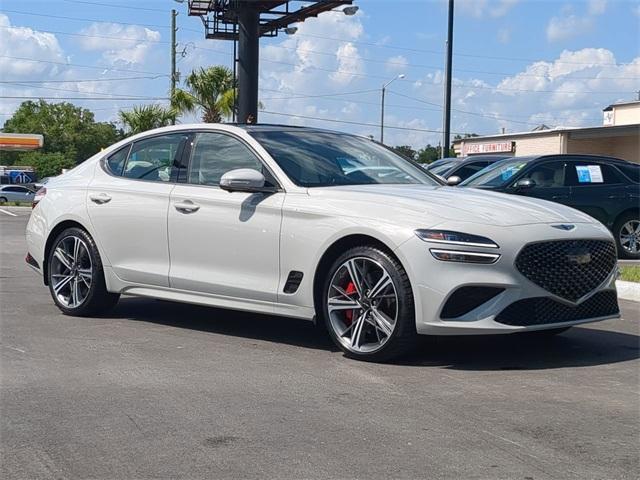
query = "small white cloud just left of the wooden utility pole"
xmin=80 ymin=23 xmax=160 ymax=65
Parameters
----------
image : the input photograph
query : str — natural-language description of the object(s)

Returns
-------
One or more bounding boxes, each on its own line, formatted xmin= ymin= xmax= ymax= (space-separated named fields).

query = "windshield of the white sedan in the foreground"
xmin=249 ymin=130 xmax=440 ymax=187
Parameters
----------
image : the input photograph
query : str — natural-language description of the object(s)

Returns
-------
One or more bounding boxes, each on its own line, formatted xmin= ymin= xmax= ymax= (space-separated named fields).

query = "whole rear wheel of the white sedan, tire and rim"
xmin=47 ymin=227 xmax=120 ymax=316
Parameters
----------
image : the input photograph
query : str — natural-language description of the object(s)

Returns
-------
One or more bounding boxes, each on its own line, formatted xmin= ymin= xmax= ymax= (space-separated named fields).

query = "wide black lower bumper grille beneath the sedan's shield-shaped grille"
xmin=496 ymin=290 xmax=620 ymax=326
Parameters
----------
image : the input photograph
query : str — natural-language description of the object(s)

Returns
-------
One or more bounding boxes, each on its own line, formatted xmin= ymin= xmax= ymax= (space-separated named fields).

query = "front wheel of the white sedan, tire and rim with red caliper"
xmin=322 ymin=246 xmax=418 ymax=361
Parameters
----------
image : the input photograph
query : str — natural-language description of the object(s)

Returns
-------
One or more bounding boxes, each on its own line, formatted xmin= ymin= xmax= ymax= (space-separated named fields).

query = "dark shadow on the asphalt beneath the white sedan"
xmin=108 ymin=298 xmax=640 ymax=370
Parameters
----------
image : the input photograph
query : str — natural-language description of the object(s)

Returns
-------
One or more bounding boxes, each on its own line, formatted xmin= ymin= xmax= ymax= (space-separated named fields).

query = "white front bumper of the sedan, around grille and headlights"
xmin=396 ymin=223 xmax=620 ymax=335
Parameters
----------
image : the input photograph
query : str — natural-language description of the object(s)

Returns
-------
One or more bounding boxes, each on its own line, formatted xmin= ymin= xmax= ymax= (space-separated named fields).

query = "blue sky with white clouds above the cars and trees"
xmin=0 ymin=0 xmax=640 ymax=147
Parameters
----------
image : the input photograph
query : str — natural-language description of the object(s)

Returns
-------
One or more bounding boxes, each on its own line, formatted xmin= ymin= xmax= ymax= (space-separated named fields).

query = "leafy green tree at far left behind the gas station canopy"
xmin=3 ymin=100 xmax=121 ymax=163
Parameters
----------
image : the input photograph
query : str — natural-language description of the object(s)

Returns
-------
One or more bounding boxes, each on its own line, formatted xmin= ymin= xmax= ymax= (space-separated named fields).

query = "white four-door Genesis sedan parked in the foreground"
xmin=27 ymin=124 xmax=619 ymax=360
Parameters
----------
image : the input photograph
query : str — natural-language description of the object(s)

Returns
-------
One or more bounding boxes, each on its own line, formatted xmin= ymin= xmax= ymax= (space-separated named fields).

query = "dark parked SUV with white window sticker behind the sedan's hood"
xmin=460 ymin=155 xmax=640 ymax=259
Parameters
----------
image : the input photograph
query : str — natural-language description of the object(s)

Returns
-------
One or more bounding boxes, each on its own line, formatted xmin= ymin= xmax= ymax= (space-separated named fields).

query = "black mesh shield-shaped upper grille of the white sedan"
xmin=516 ymin=240 xmax=616 ymax=302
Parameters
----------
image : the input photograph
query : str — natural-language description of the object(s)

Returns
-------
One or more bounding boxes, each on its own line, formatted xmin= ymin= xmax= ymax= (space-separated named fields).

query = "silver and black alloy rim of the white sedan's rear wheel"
xmin=50 ymin=235 xmax=93 ymax=308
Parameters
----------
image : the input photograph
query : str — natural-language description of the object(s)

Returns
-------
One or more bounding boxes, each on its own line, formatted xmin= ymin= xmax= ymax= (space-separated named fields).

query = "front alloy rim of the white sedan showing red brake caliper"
xmin=327 ymin=257 xmax=398 ymax=353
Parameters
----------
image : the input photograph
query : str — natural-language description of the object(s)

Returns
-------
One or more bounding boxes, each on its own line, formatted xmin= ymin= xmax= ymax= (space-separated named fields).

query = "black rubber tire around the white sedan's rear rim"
xmin=47 ymin=227 xmax=120 ymax=317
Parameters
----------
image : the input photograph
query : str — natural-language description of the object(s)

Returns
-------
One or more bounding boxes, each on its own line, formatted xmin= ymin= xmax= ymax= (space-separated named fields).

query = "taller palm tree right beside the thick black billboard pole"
xmin=171 ymin=65 xmax=234 ymax=123
